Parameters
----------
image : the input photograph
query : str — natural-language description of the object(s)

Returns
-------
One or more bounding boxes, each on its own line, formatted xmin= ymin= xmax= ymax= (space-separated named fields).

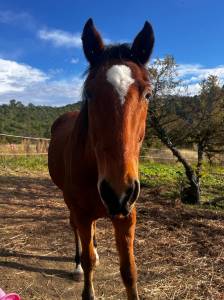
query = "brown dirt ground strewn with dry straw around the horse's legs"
xmin=0 ymin=174 xmax=224 ymax=300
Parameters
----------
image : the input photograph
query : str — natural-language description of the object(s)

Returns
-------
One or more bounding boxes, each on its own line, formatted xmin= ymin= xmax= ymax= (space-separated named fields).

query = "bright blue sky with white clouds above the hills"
xmin=0 ymin=0 xmax=224 ymax=105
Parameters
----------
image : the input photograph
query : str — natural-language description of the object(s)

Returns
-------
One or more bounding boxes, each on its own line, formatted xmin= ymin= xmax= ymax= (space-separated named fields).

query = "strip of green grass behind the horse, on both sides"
xmin=0 ymin=156 xmax=224 ymax=207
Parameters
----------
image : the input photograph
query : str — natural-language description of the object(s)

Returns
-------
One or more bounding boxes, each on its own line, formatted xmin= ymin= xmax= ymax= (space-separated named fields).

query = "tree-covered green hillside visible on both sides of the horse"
xmin=0 ymin=97 xmax=198 ymax=142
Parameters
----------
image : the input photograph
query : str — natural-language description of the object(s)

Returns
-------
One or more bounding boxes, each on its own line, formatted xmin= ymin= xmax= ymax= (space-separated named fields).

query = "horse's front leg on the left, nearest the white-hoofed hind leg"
xmin=77 ymin=219 xmax=96 ymax=300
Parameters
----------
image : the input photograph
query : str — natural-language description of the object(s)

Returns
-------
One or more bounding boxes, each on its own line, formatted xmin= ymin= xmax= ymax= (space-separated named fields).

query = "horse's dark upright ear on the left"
xmin=82 ymin=18 xmax=104 ymax=65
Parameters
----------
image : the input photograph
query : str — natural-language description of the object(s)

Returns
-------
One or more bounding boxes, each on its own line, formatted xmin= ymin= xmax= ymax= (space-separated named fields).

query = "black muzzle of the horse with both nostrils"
xmin=98 ymin=179 xmax=140 ymax=217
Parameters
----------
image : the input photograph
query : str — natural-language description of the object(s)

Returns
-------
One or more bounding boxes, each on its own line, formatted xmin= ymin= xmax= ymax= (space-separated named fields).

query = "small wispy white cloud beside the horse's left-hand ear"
xmin=38 ymin=29 xmax=82 ymax=48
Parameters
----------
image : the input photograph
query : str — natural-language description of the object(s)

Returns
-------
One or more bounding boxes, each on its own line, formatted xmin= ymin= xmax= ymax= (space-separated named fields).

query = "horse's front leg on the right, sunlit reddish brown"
xmin=112 ymin=208 xmax=139 ymax=300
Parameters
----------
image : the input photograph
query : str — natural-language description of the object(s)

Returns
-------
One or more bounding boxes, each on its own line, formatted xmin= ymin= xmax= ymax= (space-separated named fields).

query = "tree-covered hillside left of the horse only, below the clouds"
xmin=0 ymin=100 xmax=80 ymax=138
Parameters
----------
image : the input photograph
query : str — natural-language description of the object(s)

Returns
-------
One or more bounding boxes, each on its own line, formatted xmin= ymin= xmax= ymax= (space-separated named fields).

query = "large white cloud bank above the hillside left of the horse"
xmin=0 ymin=59 xmax=83 ymax=106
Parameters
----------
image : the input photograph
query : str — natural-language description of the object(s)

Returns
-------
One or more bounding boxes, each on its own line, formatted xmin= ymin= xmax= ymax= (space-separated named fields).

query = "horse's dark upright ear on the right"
xmin=131 ymin=21 xmax=155 ymax=65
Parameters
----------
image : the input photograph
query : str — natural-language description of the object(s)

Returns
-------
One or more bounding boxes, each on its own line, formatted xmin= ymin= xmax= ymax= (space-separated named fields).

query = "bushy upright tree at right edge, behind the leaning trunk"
xmin=190 ymin=75 xmax=224 ymax=165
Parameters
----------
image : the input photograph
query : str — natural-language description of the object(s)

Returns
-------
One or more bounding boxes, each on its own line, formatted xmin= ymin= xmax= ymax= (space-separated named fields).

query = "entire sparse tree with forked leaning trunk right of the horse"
xmin=149 ymin=56 xmax=224 ymax=204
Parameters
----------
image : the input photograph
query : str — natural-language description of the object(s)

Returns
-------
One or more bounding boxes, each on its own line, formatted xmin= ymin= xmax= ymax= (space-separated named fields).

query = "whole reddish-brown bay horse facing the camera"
xmin=48 ymin=19 xmax=154 ymax=300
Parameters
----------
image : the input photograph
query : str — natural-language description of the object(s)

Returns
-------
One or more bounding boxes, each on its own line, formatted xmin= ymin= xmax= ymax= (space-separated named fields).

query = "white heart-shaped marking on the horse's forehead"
xmin=107 ymin=65 xmax=134 ymax=104
